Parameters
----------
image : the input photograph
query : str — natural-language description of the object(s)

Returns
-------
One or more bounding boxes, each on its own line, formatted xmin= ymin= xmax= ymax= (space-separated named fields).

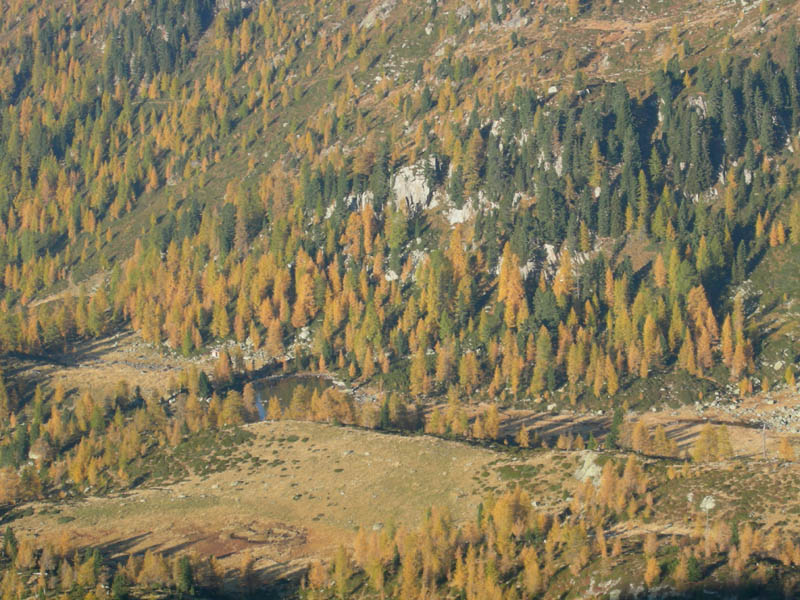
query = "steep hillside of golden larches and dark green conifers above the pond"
xmin=0 ymin=2 xmax=800 ymax=400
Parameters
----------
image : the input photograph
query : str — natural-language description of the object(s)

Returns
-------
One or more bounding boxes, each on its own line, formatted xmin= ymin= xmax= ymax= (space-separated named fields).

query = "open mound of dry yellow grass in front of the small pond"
xmin=14 ymin=421 xmax=546 ymax=574
